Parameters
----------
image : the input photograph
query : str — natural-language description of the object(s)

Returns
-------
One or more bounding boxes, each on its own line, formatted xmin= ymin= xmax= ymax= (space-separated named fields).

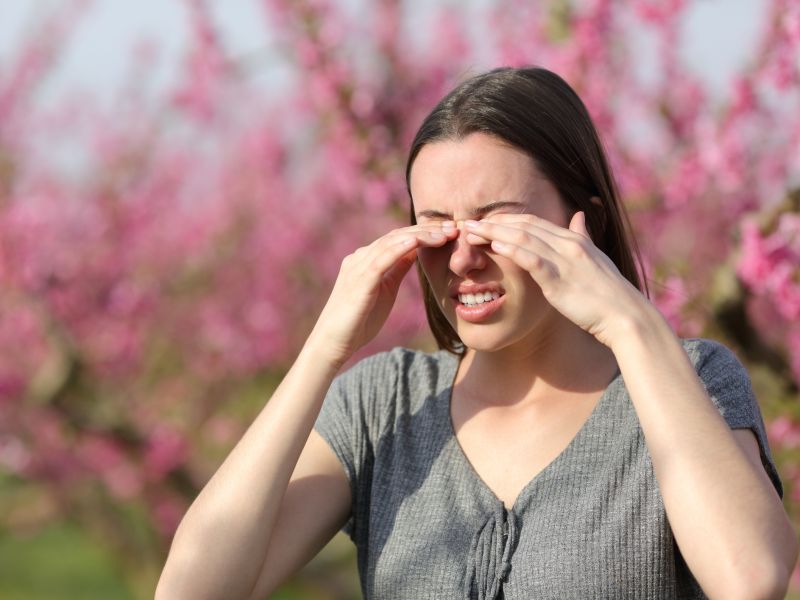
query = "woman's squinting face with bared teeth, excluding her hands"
xmin=410 ymin=133 xmax=568 ymax=351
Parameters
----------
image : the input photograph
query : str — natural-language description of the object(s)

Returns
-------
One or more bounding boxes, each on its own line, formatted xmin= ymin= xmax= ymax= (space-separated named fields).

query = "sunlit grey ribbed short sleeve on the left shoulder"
xmin=314 ymin=353 xmax=397 ymax=541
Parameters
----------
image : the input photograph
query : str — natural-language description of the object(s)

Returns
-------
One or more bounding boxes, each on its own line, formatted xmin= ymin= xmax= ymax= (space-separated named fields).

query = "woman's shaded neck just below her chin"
xmin=456 ymin=318 xmax=617 ymax=407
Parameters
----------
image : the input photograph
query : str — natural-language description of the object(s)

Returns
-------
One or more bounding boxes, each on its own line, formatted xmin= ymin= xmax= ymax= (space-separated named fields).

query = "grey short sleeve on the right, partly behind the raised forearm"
xmin=687 ymin=340 xmax=783 ymax=498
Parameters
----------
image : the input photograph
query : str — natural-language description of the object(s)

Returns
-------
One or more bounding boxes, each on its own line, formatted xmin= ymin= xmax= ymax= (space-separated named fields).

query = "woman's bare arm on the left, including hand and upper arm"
xmin=156 ymin=225 xmax=453 ymax=600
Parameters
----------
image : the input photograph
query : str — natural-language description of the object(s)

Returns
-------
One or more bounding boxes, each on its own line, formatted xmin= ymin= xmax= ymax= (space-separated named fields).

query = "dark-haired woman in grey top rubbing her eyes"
xmin=157 ymin=69 xmax=797 ymax=600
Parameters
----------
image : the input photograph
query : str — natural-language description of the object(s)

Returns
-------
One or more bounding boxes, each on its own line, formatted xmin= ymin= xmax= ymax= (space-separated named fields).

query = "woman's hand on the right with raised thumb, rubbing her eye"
xmin=464 ymin=212 xmax=653 ymax=347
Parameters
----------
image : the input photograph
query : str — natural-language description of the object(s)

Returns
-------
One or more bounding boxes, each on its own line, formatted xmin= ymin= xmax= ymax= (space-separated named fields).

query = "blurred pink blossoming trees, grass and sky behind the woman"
xmin=0 ymin=0 xmax=800 ymax=600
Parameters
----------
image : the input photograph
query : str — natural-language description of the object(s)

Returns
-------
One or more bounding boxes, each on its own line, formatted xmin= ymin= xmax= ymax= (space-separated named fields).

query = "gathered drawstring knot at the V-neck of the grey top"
xmin=465 ymin=505 xmax=519 ymax=600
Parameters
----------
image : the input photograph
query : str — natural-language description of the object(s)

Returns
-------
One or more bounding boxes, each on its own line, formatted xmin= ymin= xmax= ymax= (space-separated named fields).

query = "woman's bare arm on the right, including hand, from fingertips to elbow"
xmin=466 ymin=212 xmax=798 ymax=600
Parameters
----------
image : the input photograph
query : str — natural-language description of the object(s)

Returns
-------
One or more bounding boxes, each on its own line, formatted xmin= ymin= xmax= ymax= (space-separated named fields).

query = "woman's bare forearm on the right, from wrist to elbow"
xmin=612 ymin=307 xmax=795 ymax=597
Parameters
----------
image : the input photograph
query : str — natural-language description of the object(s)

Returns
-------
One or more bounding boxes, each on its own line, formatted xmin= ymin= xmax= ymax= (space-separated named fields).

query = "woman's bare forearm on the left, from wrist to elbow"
xmin=158 ymin=340 xmax=338 ymax=599
